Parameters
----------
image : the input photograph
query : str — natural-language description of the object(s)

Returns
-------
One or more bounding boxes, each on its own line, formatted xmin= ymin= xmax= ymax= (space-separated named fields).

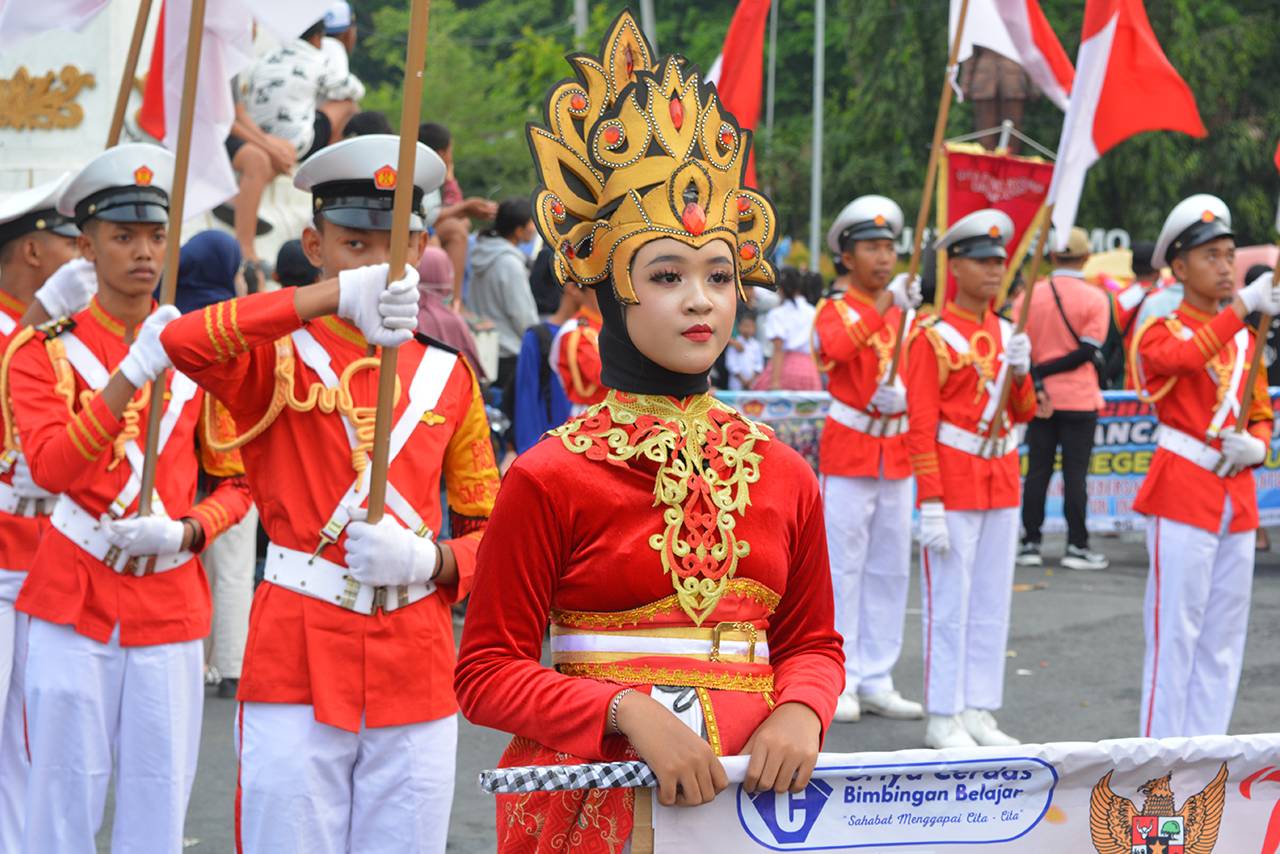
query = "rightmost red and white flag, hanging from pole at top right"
xmin=1048 ymin=0 xmax=1208 ymax=250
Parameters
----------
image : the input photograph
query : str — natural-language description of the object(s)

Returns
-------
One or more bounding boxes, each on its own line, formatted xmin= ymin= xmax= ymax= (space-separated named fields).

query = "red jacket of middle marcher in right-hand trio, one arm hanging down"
xmin=906 ymin=303 xmax=1036 ymax=510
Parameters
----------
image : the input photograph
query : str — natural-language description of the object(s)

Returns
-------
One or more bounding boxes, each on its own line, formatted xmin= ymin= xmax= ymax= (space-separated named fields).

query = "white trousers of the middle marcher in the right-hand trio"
xmin=920 ymin=507 xmax=1018 ymax=714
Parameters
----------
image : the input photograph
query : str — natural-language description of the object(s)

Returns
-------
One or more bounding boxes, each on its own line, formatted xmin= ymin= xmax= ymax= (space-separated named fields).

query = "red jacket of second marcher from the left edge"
xmin=8 ymin=300 xmax=250 ymax=647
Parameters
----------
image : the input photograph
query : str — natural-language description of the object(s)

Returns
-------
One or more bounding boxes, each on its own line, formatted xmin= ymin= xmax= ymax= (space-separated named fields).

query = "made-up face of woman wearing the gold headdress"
xmin=625 ymin=237 xmax=737 ymax=374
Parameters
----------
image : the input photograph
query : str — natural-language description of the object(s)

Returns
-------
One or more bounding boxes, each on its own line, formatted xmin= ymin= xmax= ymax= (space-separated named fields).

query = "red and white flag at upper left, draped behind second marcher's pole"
xmin=138 ymin=0 xmax=329 ymax=219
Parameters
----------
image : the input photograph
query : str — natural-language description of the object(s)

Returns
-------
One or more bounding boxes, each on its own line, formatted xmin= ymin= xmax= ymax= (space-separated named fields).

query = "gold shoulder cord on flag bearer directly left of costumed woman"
xmin=204 ymin=337 xmax=402 ymax=474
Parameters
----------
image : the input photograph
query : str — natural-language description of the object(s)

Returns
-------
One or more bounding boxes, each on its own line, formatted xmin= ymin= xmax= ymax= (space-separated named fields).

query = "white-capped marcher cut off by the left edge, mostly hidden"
xmin=0 ymin=174 xmax=80 ymax=851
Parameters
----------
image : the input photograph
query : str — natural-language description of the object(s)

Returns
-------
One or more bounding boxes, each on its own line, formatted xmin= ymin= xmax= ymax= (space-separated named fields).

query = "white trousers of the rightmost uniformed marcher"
xmin=1139 ymin=514 xmax=1254 ymax=739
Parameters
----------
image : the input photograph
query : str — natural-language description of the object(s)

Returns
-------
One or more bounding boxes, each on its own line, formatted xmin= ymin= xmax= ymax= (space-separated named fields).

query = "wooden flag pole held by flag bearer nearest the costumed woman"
xmin=369 ymin=0 xmax=431 ymax=524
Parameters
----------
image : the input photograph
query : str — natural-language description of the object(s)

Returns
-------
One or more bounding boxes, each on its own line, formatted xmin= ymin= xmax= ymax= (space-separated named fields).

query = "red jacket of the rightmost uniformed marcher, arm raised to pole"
xmin=1133 ymin=302 xmax=1275 ymax=533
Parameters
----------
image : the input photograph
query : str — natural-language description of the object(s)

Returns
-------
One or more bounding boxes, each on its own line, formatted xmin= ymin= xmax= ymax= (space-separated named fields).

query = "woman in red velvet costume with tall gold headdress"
xmin=457 ymin=13 xmax=844 ymax=854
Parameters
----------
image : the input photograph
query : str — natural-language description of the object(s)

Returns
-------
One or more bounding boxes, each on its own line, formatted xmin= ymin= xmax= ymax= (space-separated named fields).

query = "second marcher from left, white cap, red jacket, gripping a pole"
xmin=3 ymin=145 xmax=250 ymax=854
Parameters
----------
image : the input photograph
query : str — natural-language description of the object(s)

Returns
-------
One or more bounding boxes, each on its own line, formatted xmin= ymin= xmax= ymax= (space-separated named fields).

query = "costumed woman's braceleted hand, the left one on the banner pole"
xmin=617 ymin=691 xmax=727 ymax=807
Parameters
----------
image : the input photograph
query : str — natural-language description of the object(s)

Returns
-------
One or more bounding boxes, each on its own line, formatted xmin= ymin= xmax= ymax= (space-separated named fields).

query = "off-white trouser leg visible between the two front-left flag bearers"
xmin=200 ymin=506 xmax=257 ymax=679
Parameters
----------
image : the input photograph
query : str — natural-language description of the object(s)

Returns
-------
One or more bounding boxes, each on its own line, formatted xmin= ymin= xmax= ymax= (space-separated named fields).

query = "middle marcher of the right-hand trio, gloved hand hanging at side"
xmin=906 ymin=209 xmax=1036 ymax=748
